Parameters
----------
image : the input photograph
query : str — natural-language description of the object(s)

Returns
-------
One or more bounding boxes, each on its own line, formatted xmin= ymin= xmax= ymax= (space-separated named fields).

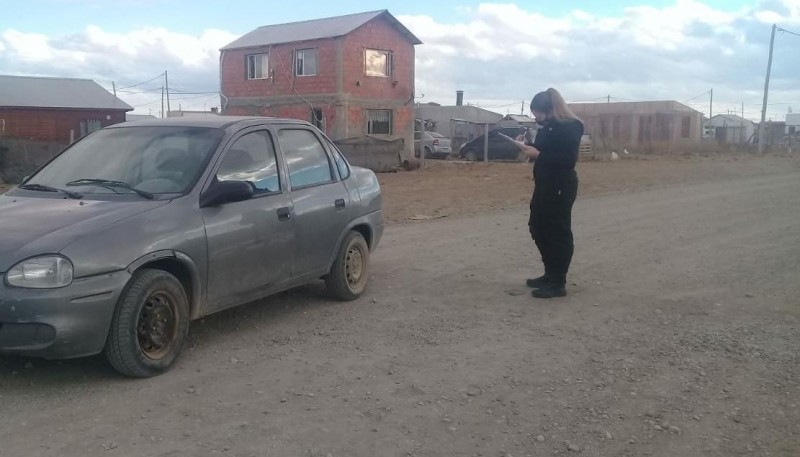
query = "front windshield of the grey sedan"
xmin=26 ymin=126 xmax=223 ymax=198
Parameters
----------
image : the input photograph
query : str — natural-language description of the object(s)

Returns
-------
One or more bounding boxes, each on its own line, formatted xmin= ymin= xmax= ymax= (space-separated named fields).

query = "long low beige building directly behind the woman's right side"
xmin=569 ymin=101 xmax=703 ymax=148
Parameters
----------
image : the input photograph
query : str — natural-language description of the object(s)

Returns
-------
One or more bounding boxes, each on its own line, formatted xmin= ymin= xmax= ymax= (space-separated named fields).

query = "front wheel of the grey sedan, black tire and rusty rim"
xmin=105 ymin=269 xmax=189 ymax=378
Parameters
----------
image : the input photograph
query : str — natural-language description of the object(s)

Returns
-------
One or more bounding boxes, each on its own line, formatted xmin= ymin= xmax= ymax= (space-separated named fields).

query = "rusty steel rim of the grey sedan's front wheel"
xmin=136 ymin=292 xmax=178 ymax=360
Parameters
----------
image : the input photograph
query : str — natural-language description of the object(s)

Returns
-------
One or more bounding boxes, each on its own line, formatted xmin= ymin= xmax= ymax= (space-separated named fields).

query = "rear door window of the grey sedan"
xmin=278 ymin=129 xmax=333 ymax=188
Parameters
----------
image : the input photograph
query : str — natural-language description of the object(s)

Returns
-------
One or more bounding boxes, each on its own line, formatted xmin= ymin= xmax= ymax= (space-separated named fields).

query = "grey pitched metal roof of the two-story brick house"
xmin=222 ymin=10 xmax=422 ymax=51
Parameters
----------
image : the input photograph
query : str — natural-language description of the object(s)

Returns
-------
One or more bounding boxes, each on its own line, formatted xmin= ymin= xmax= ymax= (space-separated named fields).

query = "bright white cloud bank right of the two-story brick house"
xmin=399 ymin=0 xmax=800 ymax=118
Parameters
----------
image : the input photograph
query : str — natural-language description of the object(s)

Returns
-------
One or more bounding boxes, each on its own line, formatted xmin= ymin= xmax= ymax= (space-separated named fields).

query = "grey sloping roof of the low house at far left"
xmin=0 ymin=75 xmax=133 ymax=111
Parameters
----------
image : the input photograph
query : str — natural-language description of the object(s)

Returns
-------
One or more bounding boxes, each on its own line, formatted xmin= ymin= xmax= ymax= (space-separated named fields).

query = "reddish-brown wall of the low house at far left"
xmin=0 ymin=108 xmax=125 ymax=143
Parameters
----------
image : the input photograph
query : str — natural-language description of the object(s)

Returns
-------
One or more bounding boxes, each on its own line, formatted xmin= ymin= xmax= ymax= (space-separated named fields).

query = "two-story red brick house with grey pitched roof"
xmin=220 ymin=10 xmax=422 ymax=156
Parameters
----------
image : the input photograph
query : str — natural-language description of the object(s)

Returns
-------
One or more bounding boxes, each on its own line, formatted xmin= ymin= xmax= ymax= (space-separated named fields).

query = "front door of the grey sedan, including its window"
xmin=202 ymin=129 xmax=295 ymax=311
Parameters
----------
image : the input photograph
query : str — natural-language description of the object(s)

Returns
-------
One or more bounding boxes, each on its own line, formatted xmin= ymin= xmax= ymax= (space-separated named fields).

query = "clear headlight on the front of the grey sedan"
xmin=6 ymin=255 xmax=73 ymax=289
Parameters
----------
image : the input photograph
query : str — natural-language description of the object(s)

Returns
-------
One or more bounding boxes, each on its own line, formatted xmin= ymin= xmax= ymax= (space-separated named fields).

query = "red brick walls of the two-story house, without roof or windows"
xmin=221 ymin=18 xmax=414 ymax=156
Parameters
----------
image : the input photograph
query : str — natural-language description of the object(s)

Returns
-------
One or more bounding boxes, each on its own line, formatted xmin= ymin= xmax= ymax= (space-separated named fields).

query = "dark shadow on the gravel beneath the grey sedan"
xmin=0 ymin=281 xmax=339 ymax=386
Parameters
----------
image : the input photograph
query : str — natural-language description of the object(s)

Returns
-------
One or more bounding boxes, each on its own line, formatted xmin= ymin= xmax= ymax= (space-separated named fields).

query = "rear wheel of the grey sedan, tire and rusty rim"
xmin=325 ymin=231 xmax=369 ymax=301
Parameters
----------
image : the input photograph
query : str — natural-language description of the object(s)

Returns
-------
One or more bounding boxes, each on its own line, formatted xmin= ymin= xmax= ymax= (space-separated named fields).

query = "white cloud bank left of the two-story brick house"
xmin=0 ymin=25 xmax=238 ymax=112
